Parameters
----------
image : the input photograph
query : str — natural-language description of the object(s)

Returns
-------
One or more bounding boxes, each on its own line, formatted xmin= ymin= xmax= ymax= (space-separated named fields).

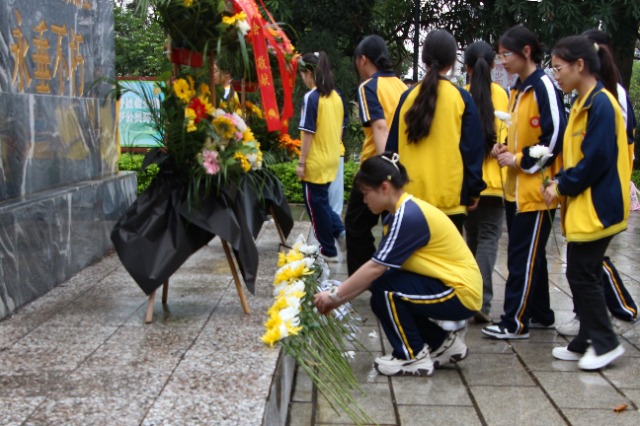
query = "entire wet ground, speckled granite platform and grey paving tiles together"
xmin=0 ymin=210 xmax=640 ymax=426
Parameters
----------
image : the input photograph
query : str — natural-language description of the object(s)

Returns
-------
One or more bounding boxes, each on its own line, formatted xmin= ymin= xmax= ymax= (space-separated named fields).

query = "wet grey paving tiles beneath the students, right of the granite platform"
xmin=288 ymin=213 xmax=640 ymax=426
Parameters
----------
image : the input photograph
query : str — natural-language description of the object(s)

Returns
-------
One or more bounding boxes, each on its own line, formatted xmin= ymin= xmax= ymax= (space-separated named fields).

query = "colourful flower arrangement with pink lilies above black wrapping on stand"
xmin=140 ymin=70 xmax=262 ymax=200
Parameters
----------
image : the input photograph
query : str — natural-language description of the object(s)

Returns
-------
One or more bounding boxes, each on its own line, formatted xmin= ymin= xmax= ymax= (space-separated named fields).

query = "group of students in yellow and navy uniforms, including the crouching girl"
xmin=296 ymin=25 xmax=638 ymax=375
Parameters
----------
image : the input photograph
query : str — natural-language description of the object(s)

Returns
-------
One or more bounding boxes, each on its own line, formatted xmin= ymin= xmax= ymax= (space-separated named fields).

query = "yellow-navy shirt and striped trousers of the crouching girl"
xmin=370 ymin=193 xmax=482 ymax=359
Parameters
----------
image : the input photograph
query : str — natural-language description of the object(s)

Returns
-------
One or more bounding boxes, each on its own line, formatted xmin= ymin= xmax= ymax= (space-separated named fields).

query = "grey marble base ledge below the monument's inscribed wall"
xmin=0 ymin=172 xmax=137 ymax=319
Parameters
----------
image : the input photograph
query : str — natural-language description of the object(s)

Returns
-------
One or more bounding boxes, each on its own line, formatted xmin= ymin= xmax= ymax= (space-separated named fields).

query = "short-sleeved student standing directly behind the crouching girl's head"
xmin=345 ymin=35 xmax=407 ymax=274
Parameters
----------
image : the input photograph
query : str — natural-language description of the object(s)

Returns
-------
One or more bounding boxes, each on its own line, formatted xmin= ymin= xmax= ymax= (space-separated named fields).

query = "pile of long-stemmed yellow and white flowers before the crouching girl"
xmin=262 ymin=237 xmax=375 ymax=424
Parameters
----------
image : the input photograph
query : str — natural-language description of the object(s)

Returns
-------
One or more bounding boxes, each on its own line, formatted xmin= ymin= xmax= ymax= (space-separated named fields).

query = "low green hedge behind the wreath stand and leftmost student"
xmin=119 ymin=153 xmax=358 ymax=203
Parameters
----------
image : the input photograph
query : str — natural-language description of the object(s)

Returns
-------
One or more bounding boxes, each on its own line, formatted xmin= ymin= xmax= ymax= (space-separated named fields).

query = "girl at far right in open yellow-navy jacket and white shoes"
xmin=543 ymin=36 xmax=630 ymax=370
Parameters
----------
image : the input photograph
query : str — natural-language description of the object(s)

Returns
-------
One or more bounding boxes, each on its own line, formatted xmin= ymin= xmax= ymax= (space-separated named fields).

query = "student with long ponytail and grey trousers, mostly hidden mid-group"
xmin=464 ymin=41 xmax=509 ymax=323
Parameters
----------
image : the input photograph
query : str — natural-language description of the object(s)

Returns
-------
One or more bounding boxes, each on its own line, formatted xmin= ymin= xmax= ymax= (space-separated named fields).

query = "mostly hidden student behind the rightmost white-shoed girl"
xmin=556 ymin=29 xmax=638 ymax=336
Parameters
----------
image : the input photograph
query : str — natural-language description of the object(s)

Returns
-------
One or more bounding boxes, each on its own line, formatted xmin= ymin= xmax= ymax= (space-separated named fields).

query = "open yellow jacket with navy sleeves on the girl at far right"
xmin=558 ymin=82 xmax=631 ymax=242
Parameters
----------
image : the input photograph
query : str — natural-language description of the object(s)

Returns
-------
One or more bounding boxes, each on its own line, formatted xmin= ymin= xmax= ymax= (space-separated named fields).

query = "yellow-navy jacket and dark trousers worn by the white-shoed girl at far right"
xmin=557 ymin=82 xmax=631 ymax=355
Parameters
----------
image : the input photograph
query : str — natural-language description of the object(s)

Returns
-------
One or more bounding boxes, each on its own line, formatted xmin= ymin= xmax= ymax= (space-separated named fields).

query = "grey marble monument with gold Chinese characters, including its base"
xmin=0 ymin=0 xmax=136 ymax=318
